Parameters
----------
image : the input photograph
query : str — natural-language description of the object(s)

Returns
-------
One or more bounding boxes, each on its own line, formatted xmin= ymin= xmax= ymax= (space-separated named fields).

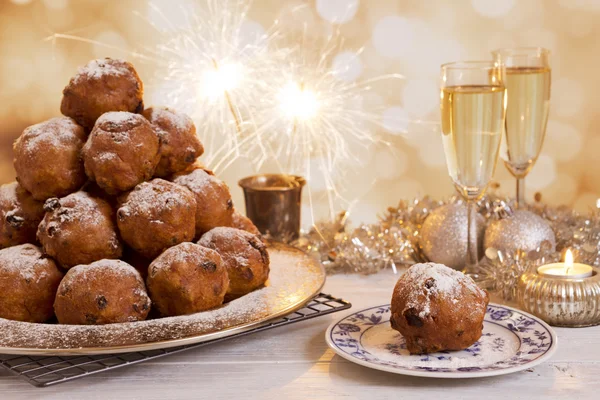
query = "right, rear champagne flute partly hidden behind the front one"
xmin=492 ymin=47 xmax=551 ymax=207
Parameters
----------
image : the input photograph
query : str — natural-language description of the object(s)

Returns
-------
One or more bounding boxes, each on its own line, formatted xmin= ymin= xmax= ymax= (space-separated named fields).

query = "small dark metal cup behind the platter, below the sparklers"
xmin=238 ymin=174 xmax=306 ymax=243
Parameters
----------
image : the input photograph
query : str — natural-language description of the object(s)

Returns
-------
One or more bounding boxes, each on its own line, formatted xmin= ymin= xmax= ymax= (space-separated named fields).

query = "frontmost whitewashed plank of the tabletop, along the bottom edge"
xmin=0 ymin=360 xmax=600 ymax=400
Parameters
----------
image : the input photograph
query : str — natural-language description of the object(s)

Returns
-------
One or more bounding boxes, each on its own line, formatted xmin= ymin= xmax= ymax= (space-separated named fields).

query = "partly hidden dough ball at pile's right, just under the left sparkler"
xmin=142 ymin=107 xmax=204 ymax=178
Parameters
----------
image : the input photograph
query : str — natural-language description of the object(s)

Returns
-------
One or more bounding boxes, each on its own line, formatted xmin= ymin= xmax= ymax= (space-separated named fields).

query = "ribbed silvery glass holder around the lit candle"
xmin=517 ymin=267 xmax=600 ymax=327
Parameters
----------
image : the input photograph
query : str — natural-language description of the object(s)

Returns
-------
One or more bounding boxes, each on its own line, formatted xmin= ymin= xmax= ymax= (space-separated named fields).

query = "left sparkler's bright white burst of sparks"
xmin=142 ymin=0 xmax=278 ymax=167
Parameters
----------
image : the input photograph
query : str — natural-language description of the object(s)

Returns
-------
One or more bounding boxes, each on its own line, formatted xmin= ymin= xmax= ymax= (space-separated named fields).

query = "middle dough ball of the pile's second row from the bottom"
xmin=117 ymin=178 xmax=196 ymax=259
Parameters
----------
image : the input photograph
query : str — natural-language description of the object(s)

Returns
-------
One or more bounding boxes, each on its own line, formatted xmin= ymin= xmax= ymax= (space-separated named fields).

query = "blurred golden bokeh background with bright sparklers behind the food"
xmin=0 ymin=0 xmax=600 ymax=222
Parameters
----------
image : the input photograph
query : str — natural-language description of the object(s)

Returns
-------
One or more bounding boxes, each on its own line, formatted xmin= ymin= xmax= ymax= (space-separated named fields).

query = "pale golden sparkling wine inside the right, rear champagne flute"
xmin=503 ymin=67 xmax=550 ymax=178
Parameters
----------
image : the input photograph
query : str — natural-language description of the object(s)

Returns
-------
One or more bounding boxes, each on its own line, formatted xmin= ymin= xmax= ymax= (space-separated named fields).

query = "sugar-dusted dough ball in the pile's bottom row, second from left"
xmin=54 ymin=260 xmax=151 ymax=325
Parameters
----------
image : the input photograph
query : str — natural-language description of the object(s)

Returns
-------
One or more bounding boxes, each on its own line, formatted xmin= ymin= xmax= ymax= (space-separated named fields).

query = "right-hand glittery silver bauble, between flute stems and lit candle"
xmin=484 ymin=210 xmax=556 ymax=253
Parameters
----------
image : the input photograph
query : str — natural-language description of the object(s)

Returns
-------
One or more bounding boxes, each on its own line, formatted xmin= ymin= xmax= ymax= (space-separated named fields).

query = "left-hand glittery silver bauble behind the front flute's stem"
xmin=419 ymin=203 xmax=485 ymax=270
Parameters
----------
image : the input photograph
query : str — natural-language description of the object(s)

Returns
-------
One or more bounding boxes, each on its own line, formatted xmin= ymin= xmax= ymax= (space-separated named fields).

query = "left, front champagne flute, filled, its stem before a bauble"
xmin=440 ymin=61 xmax=506 ymax=275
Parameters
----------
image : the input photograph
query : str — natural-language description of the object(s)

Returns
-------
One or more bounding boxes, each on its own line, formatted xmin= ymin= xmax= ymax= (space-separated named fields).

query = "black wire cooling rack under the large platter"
xmin=0 ymin=293 xmax=352 ymax=387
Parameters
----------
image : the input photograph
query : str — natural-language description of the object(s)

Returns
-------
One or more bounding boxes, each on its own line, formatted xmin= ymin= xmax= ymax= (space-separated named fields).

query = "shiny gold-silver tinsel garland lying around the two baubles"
xmin=294 ymin=192 xmax=600 ymax=299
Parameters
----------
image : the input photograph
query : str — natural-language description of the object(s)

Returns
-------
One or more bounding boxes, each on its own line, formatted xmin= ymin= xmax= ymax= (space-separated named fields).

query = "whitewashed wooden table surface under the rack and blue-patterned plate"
xmin=0 ymin=271 xmax=600 ymax=400
